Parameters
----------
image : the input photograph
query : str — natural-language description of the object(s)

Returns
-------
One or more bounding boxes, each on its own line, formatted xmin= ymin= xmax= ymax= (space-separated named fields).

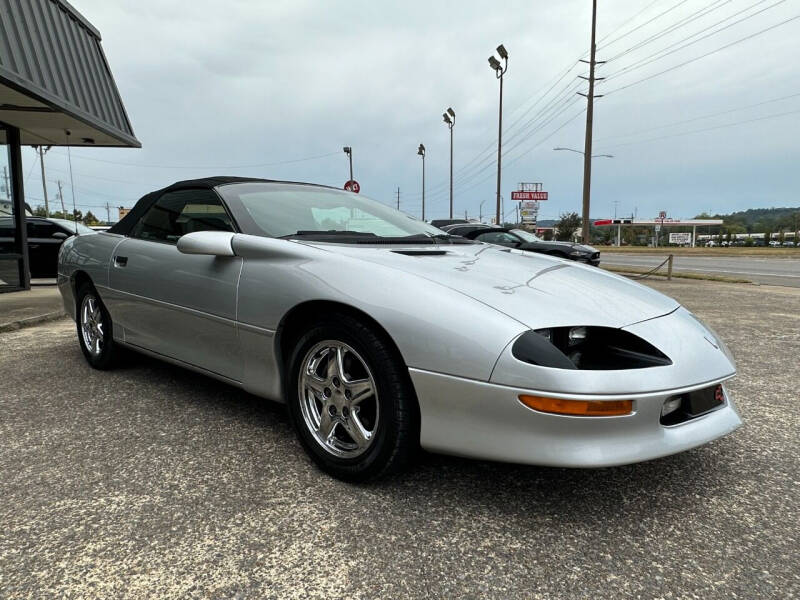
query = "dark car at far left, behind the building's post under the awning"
xmin=0 ymin=217 xmax=95 ymax=279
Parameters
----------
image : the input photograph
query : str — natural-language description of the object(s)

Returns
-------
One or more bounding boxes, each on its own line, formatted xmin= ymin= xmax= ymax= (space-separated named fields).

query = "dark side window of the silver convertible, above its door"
xmin=131 ymin=190 xmax=234 ymax=244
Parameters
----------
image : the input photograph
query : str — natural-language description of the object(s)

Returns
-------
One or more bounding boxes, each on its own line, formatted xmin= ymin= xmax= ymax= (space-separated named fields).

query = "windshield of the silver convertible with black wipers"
xmin=217 ymin=182 xmax=447 ymax=243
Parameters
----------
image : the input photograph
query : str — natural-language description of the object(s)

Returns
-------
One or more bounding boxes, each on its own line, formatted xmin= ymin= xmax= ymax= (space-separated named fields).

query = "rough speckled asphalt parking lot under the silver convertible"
xmin=0 ymin=281 xmax=800 ymax=599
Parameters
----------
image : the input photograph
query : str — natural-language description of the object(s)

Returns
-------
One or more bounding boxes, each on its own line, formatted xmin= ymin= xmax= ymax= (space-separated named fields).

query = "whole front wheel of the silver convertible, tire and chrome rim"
xmin=286 ymin=314 xmax=419 ymax=481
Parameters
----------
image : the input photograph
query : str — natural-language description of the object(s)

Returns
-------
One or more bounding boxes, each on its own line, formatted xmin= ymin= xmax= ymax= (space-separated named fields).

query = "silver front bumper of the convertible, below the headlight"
xmin=409 ymin=368 xmax=742 ymax=467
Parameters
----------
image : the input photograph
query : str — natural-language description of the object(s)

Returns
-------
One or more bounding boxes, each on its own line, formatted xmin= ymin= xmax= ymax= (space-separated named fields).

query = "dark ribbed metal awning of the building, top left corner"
xmin=0 ymin=0 xmax=141 ymax=148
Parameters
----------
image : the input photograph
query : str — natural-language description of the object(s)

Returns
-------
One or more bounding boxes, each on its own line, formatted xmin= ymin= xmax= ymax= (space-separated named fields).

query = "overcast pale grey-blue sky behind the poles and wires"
xmin=24 ymin=0 xmax=800 ymax=220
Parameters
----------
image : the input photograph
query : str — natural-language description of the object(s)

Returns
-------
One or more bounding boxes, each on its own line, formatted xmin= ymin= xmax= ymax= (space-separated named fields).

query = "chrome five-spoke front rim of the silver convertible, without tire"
xmin=297 ymin=340 xmax=380 ymax=458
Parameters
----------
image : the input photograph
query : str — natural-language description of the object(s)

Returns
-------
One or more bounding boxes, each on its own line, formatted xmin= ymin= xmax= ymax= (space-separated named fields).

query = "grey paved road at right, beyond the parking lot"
xmin=600 ymin=250 xmax=800 ymax=287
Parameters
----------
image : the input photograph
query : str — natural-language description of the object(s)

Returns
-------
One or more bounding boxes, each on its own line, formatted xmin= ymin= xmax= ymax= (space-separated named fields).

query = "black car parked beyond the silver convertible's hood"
xmin=442 ymin=223 xmax=600 ymax=267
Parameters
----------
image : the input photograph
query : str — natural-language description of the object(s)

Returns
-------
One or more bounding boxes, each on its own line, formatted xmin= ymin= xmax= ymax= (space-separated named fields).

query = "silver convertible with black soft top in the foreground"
xmin=58 ymin=177 xmax=741 ymax=481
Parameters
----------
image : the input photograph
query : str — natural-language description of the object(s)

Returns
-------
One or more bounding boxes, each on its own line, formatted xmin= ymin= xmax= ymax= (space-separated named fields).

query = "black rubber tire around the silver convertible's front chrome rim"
xmin=284 ymin=314 xmax=419 ymax=482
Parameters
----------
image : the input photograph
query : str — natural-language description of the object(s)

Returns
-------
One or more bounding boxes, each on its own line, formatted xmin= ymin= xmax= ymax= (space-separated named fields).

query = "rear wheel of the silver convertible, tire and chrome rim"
xmin=75 ymin=283 xmax=118 ymax=369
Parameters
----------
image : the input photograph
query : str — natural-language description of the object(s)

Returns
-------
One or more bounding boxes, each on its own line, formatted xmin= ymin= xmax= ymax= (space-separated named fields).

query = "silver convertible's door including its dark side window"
xmin=109 ymin=189 xmax=242 ymax=381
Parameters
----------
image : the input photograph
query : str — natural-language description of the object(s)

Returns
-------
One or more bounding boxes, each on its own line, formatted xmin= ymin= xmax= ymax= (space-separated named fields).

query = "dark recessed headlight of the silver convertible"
xmin=511 ymin=326 xmax=672 ymax=371
